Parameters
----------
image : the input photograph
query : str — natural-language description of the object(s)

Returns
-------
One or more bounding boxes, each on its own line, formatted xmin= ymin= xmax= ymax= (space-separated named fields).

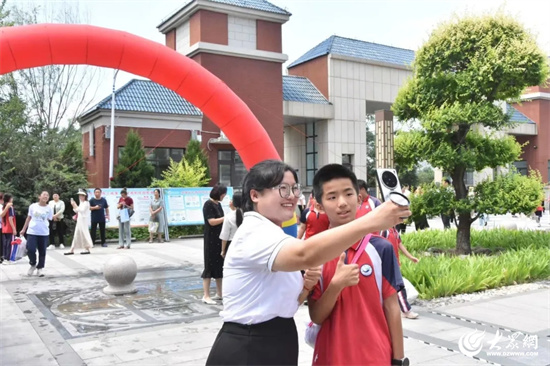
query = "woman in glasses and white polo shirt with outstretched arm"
xmin=206 ymin=160 xmax=410 ymax=365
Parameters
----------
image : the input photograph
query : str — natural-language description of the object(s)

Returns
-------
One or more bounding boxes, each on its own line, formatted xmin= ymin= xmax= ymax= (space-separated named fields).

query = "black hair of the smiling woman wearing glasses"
xmin=242 ymin=160 xmax=298 ymax=212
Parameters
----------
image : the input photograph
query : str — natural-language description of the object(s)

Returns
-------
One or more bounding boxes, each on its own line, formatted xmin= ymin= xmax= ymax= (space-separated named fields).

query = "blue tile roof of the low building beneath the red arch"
xmin=80 ymin=79 xmax=202 ymax=117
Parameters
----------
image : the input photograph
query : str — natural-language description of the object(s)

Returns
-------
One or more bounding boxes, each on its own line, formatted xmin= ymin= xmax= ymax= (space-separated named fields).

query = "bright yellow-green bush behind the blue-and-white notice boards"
xmin=150 ymin=159 xmax=210 ymax=188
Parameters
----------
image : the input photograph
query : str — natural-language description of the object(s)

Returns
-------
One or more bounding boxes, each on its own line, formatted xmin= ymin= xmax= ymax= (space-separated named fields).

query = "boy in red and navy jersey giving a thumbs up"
xmin=308 ymin=164 xmax=408 ymax=365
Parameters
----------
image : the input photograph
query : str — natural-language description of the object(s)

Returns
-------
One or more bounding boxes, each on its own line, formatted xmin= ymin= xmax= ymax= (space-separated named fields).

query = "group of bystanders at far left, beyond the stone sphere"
xmin=0 ymin=188 xmax=165 ymax=277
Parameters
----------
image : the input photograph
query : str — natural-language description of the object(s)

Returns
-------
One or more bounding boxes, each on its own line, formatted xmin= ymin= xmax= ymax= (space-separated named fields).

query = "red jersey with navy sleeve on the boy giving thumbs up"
xmin=311 ymin=237 xmax=404 ymax=365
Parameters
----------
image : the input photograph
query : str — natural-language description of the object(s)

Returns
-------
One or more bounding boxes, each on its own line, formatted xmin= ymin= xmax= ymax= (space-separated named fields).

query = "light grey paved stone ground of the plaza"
xmin=0 ymin=216 xmax=550 ymax=366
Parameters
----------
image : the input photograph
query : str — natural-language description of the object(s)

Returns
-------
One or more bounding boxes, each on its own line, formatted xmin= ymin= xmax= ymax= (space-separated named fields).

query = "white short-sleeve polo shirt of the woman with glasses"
xmin=220 ymin=212 xmax=303 ymax=324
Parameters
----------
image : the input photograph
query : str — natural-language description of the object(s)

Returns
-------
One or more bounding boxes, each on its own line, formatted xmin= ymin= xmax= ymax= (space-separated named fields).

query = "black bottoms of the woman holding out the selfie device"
xmin=206 ymin=317 xmax=298 ymax=365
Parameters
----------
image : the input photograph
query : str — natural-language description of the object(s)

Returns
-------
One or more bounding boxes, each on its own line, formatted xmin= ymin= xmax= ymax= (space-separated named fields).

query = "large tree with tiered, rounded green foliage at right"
xmin=393 ymin=14 xmax=548 ymax=254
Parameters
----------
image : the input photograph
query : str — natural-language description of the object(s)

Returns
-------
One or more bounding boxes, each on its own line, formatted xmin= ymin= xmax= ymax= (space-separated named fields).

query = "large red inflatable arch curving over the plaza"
xmin=0 ymin=24 xmax=280 ymax=169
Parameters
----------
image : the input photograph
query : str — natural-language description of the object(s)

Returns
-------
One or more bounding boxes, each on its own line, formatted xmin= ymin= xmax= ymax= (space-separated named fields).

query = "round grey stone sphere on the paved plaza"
xmin=103 ymin=255 xmax=137 ymax=295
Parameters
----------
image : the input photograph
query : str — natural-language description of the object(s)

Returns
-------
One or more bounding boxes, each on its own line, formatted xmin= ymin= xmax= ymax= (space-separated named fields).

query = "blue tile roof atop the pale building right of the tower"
xmin=288 ymin=36 xmax=414 ymax=68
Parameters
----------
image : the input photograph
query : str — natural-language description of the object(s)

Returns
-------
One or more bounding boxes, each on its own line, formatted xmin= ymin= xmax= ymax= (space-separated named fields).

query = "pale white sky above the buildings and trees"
xmin=8 ymin=0 xmax=550 ymax=108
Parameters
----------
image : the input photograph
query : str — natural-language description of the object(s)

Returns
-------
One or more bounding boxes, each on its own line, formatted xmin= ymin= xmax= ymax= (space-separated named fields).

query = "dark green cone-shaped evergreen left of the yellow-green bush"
xmin=111 ymin=130 xmax=155 ymax=188
